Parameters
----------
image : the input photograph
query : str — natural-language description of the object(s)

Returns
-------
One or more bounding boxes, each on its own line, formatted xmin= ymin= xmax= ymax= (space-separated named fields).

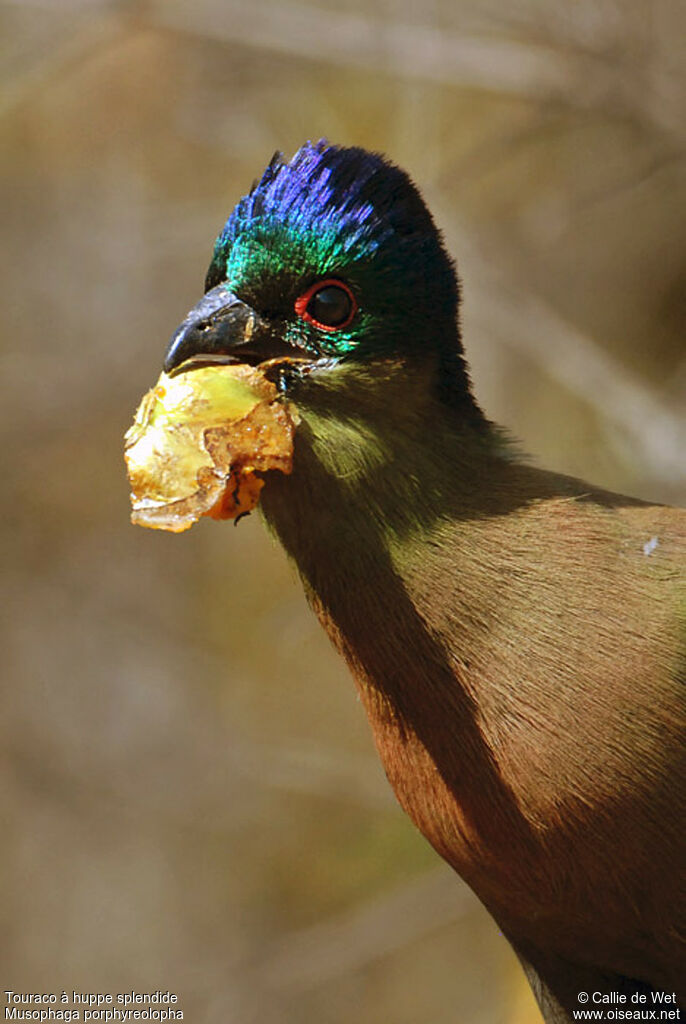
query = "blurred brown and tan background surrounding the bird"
xmin=0 ymin=0 xmax=686 ymax=1024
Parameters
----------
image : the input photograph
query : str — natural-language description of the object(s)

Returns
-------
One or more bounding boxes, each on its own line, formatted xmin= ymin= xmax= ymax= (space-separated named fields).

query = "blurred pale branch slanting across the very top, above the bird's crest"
xmin=144 ymin=0 xmax=683 ymax=140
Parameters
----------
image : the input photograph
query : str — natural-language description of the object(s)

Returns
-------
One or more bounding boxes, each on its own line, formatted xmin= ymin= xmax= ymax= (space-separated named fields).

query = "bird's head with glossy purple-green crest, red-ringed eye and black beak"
xmin=165 ymin=140 xmax=478 ymax=414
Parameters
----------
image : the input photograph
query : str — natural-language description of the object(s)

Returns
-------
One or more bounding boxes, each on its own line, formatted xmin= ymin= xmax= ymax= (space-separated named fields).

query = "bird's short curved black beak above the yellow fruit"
xmin=164 ymin=285 xmax=305 ymax=374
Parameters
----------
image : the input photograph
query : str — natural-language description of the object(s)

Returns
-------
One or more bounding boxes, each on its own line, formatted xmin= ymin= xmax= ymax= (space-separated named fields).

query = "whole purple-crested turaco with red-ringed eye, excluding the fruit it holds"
xmin=165 ymin=139 xmax=686 ymax=1024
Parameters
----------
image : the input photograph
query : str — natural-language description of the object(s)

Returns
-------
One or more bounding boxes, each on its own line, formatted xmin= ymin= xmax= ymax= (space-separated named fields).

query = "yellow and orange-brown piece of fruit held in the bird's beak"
xmin=124 ymin=365 xmax=298 ymax=532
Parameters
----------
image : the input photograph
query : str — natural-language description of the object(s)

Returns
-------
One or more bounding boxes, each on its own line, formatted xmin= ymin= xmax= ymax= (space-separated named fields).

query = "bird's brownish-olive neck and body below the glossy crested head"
xmin=263 ymin=358 xmax=686 ymax=1019
